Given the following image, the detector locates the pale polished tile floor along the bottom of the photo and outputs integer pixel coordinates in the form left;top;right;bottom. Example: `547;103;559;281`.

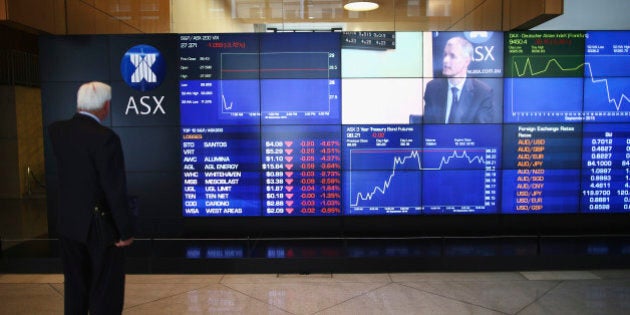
0;269;630;315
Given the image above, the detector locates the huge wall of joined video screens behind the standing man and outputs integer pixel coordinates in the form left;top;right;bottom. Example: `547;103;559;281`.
40;31;630;227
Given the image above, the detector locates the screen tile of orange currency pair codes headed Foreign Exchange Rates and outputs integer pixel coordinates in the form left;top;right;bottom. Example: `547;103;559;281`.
503;124;582;213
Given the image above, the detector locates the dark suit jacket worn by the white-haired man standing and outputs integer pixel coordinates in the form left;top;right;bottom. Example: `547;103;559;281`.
48;114;133;242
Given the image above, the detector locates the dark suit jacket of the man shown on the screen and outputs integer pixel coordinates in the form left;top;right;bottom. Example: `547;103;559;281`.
423;78;500;124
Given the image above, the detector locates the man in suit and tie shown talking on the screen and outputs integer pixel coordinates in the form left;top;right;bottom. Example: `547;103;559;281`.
423;37;499;124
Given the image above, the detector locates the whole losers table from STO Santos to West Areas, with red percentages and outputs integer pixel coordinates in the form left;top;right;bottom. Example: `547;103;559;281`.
182;126;342;216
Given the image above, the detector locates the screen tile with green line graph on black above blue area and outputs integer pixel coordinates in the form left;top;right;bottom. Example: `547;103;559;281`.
504;32;586;123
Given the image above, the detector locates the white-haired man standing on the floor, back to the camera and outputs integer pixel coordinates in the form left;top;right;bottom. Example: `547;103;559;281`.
48;82;134;314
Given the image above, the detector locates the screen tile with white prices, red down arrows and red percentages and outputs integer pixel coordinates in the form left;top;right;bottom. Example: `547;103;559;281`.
262;126;341;216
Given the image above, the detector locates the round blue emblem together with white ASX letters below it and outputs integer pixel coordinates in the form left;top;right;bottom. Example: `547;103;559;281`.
120;45;166;116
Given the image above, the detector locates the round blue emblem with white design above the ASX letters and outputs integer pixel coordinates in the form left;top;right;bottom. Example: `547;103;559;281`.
120;45;166;92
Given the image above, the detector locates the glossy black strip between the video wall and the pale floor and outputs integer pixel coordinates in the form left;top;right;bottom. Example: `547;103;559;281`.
0;236;630;274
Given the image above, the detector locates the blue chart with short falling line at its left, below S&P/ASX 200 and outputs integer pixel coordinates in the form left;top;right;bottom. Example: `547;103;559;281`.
220;51;341;120
